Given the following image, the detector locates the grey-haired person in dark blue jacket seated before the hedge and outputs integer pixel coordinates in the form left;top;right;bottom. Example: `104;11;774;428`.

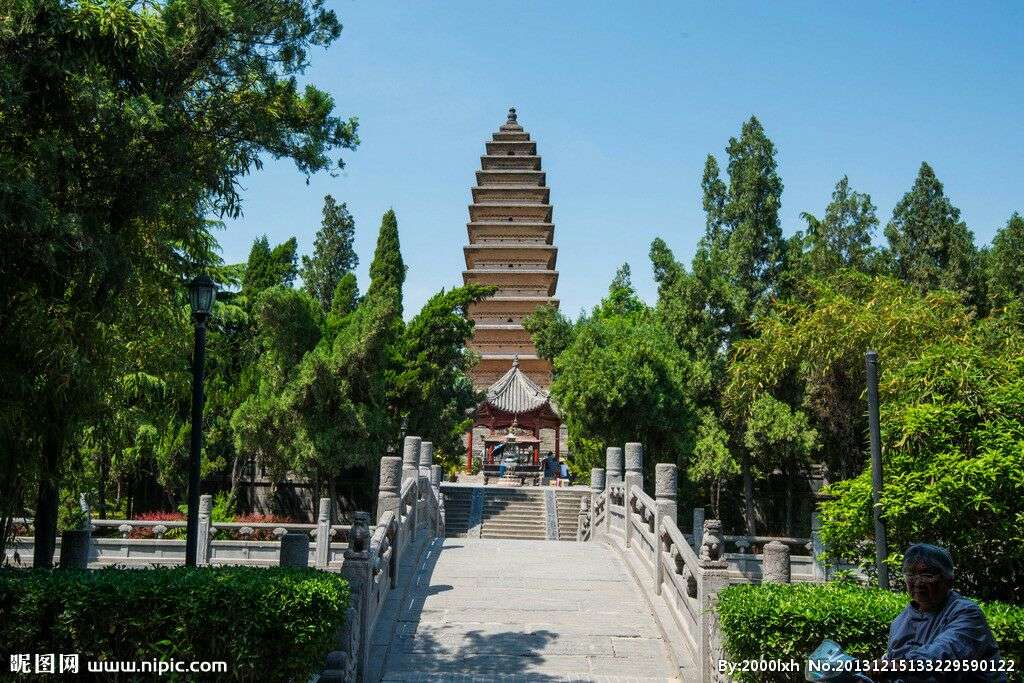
885;543;1007;681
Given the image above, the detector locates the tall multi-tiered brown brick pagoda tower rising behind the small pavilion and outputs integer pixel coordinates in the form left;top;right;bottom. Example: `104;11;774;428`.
462;109;558;389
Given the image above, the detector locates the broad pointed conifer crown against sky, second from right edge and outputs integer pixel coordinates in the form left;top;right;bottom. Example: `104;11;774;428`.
886;163;983;305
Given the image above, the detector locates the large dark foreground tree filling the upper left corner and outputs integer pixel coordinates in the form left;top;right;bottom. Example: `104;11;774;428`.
0;0;357;566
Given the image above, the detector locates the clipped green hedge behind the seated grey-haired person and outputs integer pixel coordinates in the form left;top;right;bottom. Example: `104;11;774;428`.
718;582;1024;680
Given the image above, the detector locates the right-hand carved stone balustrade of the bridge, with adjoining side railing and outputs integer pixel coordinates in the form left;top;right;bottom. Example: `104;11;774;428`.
578;443;827;681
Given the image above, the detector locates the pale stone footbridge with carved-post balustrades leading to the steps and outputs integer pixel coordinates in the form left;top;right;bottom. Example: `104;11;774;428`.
321;437;820;682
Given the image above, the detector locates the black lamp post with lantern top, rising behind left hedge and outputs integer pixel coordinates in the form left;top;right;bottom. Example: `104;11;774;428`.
185;275;217;567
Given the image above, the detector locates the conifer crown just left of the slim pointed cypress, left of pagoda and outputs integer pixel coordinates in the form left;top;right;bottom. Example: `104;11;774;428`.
302;195;359;311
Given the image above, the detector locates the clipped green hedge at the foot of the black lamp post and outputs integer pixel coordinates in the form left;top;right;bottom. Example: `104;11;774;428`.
0;567;349;681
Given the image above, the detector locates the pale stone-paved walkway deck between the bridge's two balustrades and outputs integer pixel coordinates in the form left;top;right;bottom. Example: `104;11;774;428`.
372;539;676;681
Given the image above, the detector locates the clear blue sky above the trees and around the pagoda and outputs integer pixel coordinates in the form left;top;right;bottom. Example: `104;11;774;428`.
218;0;1024;316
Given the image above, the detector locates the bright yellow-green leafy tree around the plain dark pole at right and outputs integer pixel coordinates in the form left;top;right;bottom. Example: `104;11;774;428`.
822;304;1024;602
